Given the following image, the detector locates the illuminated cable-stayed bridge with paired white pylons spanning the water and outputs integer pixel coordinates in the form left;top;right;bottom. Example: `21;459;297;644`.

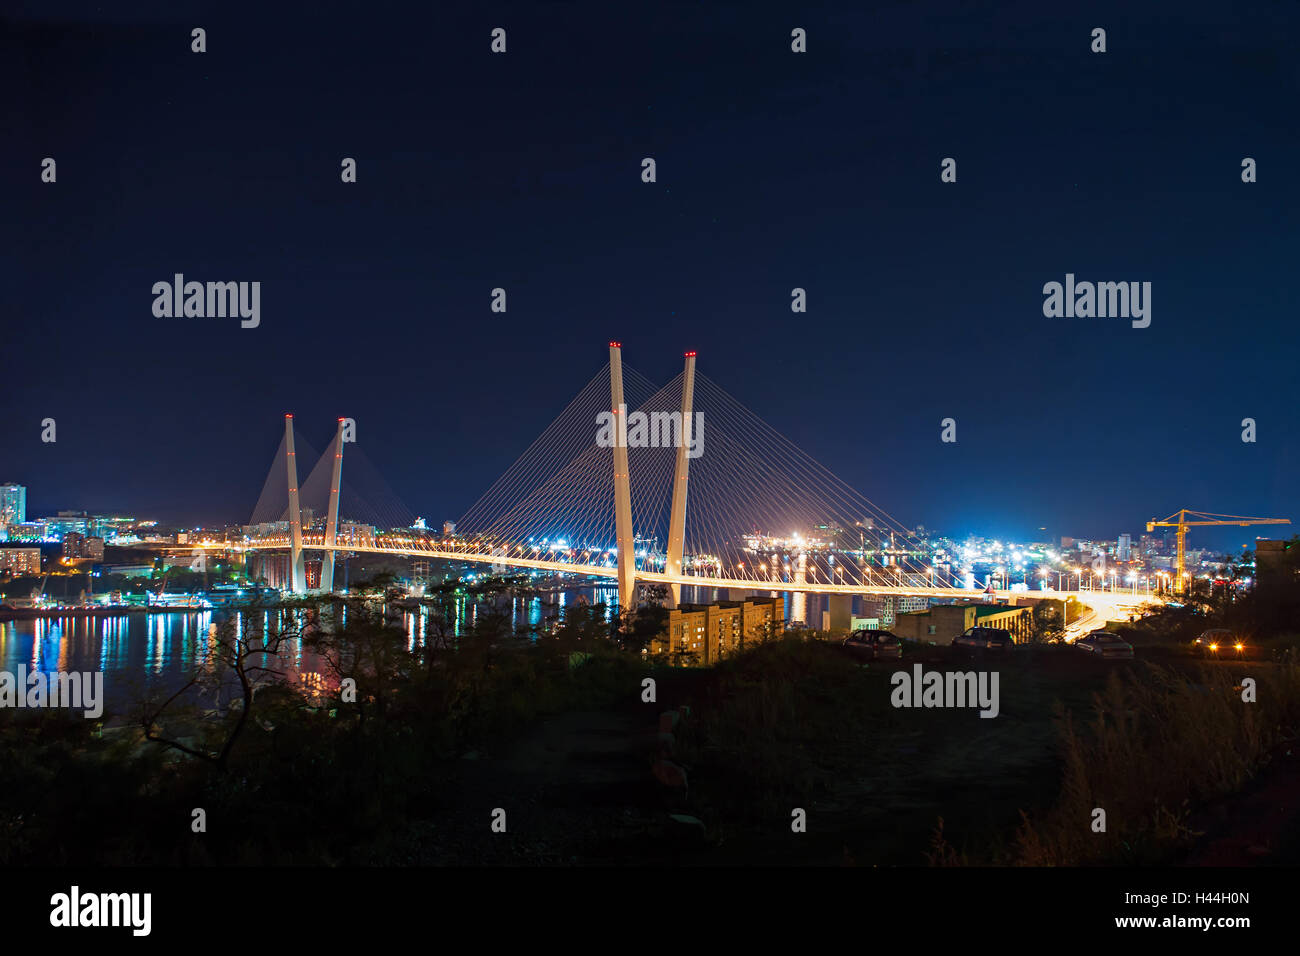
231;342;1086;607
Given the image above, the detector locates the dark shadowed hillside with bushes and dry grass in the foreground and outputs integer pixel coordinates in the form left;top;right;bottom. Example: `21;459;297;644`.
0;556;1300;865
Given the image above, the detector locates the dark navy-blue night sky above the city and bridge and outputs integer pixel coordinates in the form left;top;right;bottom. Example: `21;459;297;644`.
0;0;1300;548
